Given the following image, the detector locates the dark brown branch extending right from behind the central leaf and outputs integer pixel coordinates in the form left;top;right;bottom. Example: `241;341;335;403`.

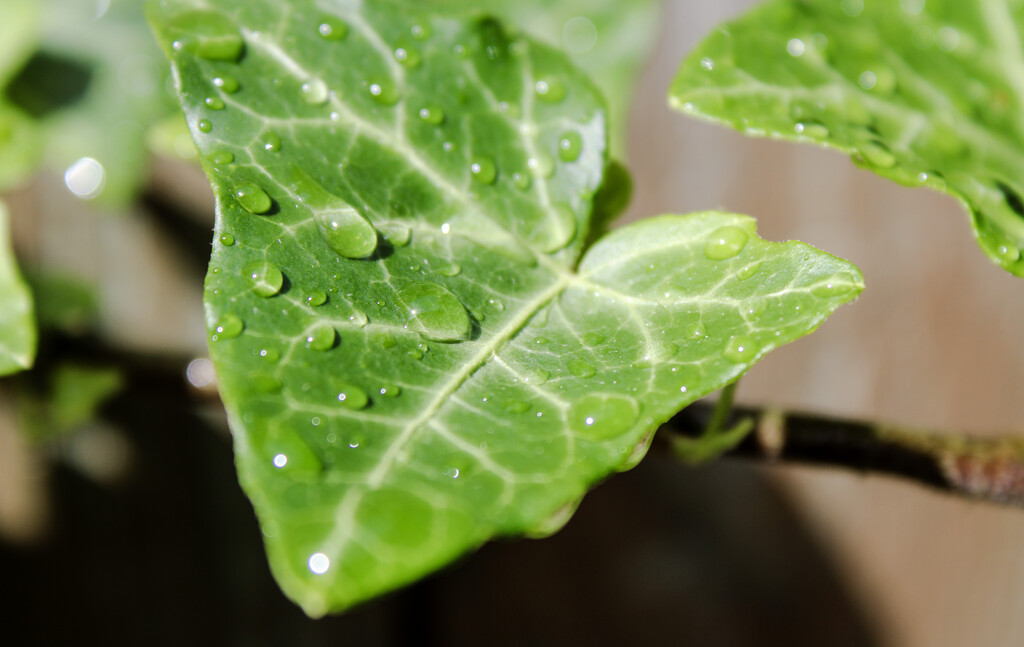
663;402;1024;507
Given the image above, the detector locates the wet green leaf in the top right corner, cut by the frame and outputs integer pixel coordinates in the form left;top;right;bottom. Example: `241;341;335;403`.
671;0;1024;275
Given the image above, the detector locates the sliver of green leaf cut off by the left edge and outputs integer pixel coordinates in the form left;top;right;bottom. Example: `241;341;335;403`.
0;202;36;376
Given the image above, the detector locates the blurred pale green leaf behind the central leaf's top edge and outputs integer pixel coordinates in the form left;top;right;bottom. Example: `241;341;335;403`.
414;0;662;158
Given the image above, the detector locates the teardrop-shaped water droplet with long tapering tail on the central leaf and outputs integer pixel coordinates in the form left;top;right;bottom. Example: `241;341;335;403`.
290;167;377;258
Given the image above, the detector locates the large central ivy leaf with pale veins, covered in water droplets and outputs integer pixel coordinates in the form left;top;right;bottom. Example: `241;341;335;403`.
152;0;861;615
